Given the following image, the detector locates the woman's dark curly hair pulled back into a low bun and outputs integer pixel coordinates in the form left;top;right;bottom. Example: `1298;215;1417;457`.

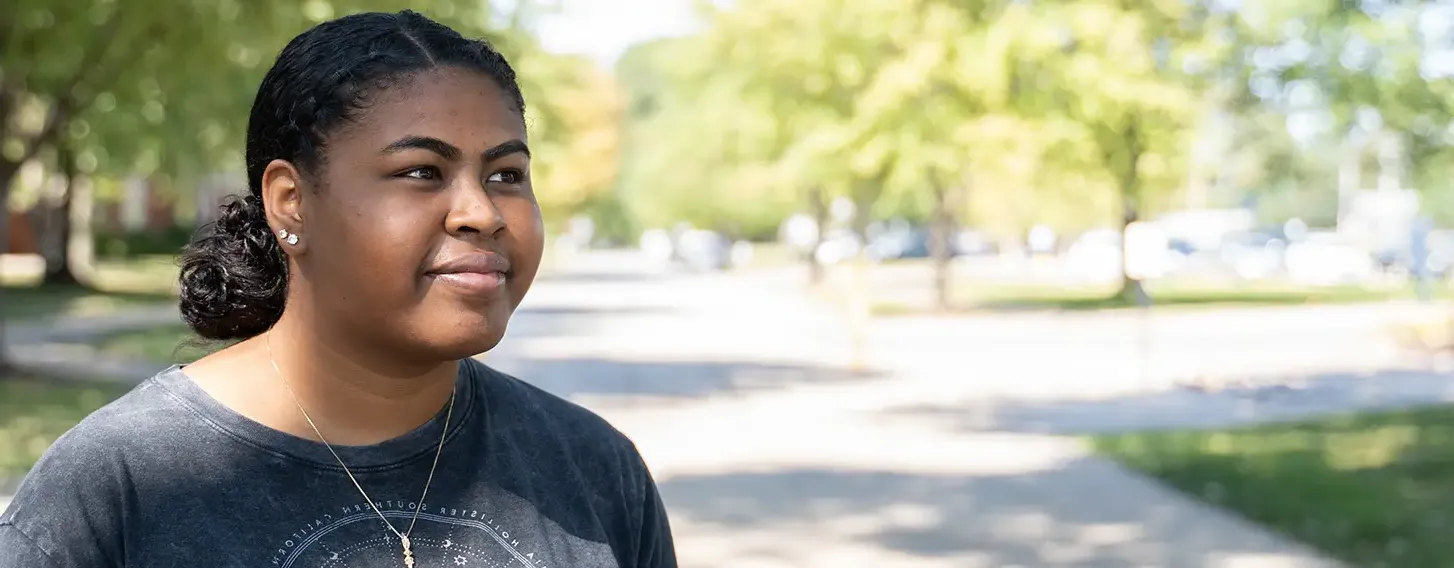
179;10;525;340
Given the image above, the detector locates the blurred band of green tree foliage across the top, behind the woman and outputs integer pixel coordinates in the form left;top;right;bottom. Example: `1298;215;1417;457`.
0;0;1454;302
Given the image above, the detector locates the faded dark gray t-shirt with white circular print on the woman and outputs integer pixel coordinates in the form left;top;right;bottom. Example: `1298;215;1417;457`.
0;360;676;568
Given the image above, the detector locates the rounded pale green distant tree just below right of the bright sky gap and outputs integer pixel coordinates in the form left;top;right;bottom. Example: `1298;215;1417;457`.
616;38;797;238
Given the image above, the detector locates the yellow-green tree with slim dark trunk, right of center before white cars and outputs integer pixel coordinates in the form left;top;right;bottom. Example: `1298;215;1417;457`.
1000;0;1230;299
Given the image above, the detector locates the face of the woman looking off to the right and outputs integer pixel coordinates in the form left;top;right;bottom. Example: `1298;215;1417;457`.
274;68;544;360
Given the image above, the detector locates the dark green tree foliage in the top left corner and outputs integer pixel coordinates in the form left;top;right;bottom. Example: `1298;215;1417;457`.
0;0;286;372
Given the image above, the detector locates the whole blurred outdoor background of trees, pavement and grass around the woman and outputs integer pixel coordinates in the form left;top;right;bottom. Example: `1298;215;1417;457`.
0;0;1454;568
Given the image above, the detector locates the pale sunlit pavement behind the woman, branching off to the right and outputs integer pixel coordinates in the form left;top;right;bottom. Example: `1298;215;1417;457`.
0;254;1451;568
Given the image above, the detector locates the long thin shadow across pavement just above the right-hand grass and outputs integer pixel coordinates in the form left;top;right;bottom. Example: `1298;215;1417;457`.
885;369;1454;434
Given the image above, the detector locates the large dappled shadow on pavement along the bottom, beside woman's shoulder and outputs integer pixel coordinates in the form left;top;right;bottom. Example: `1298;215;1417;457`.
660;459;1317;567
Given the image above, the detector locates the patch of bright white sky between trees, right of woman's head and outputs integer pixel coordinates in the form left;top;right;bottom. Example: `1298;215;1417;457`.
537;0;696;68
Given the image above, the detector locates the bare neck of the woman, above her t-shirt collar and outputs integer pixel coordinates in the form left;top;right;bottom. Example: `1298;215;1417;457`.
253;315;458;446
